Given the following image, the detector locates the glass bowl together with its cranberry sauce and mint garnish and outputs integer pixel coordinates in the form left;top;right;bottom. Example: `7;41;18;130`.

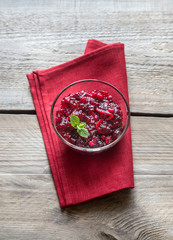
51;79;130;153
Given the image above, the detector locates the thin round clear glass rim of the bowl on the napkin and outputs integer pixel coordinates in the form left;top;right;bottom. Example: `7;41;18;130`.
50;79;130;152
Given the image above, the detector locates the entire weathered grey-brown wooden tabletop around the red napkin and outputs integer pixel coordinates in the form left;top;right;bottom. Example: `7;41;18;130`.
0;0;173;240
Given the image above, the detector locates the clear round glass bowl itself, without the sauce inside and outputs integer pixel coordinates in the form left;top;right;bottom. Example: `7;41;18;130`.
50;79;130;153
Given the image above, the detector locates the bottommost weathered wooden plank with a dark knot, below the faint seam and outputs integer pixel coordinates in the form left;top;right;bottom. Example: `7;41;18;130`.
0;175;173;240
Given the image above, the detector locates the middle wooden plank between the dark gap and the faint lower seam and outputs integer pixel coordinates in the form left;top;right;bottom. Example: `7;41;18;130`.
0;114;173;174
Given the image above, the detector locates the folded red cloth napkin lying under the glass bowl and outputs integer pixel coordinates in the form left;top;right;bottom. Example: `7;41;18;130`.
27;40;134;207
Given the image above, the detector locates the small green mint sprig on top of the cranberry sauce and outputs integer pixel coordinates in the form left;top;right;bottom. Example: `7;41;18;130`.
70;114;89;138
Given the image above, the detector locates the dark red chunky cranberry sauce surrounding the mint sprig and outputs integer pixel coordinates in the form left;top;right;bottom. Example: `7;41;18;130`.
56;90;123;148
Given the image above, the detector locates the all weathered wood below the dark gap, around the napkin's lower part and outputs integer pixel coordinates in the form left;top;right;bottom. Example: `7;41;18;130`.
0;114;173;240
